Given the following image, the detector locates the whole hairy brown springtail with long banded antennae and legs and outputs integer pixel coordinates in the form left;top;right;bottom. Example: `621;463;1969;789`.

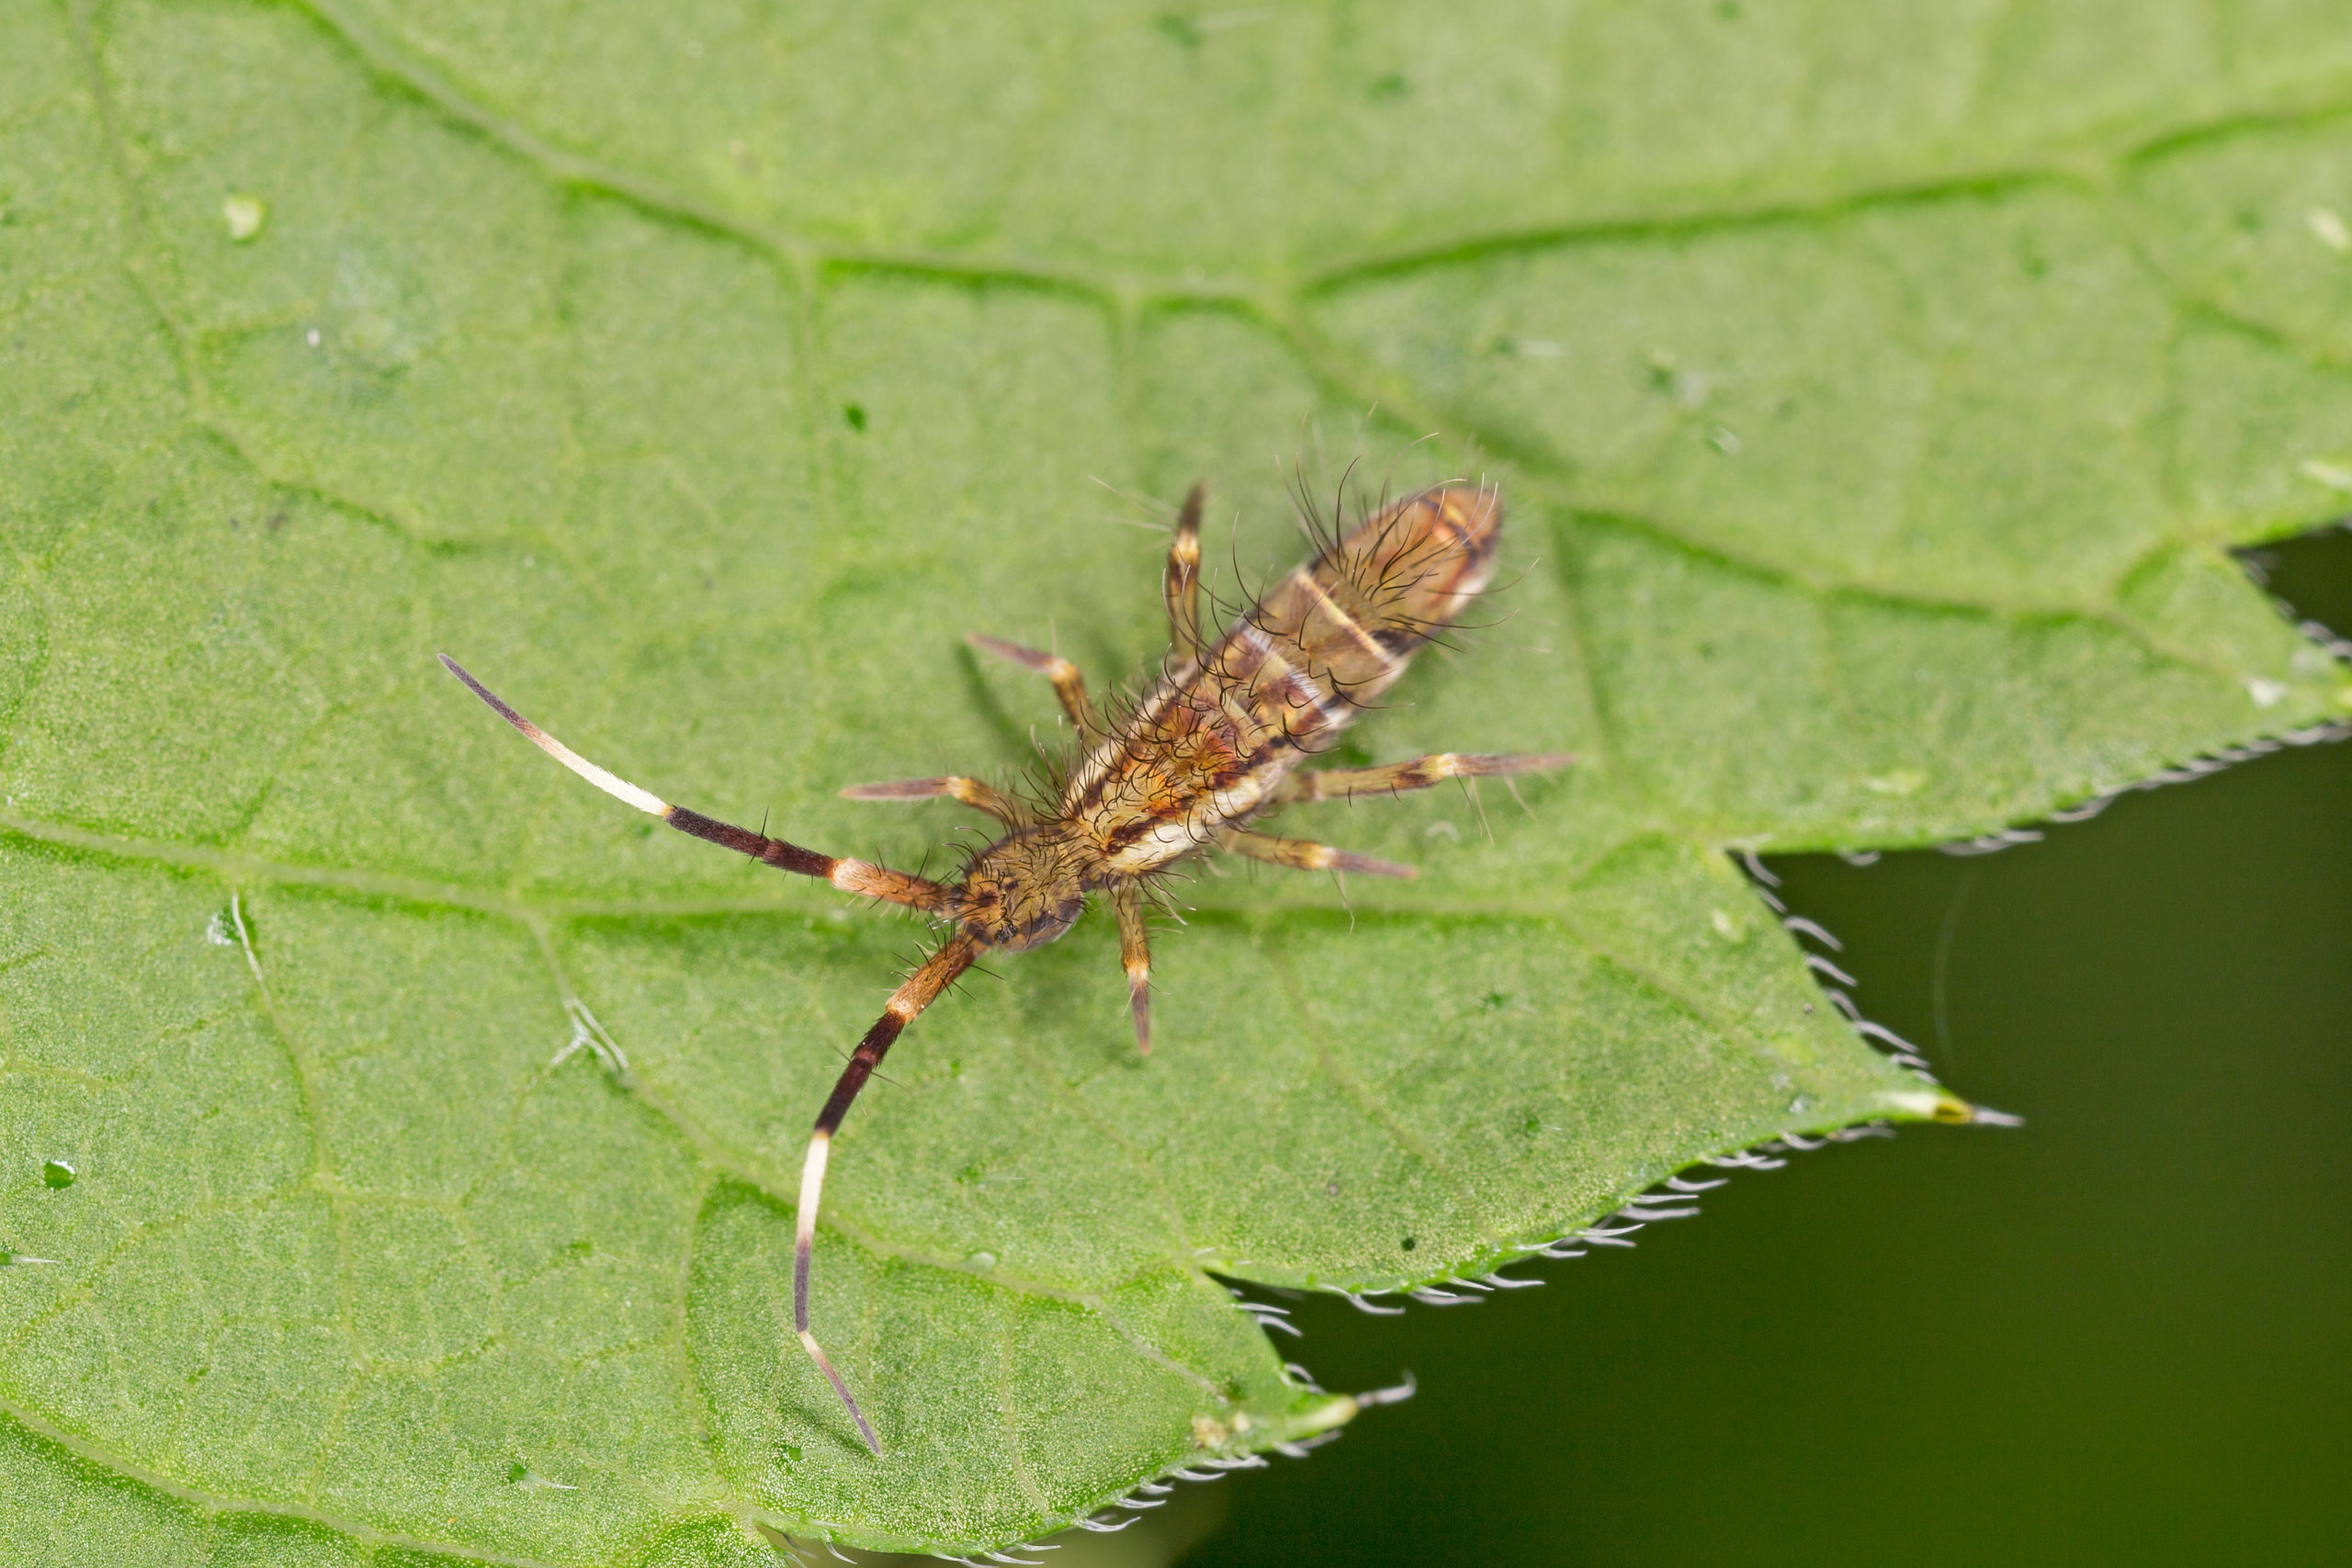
442;479;1574;1455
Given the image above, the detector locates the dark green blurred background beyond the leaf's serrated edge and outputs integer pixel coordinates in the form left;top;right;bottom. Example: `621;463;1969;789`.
1128;529;2352;1568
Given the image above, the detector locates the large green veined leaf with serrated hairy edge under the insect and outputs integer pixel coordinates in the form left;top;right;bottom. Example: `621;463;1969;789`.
0;0;2352;1563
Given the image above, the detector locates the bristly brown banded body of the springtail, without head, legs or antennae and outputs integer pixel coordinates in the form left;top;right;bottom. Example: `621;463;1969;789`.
1061;487;1503;877
